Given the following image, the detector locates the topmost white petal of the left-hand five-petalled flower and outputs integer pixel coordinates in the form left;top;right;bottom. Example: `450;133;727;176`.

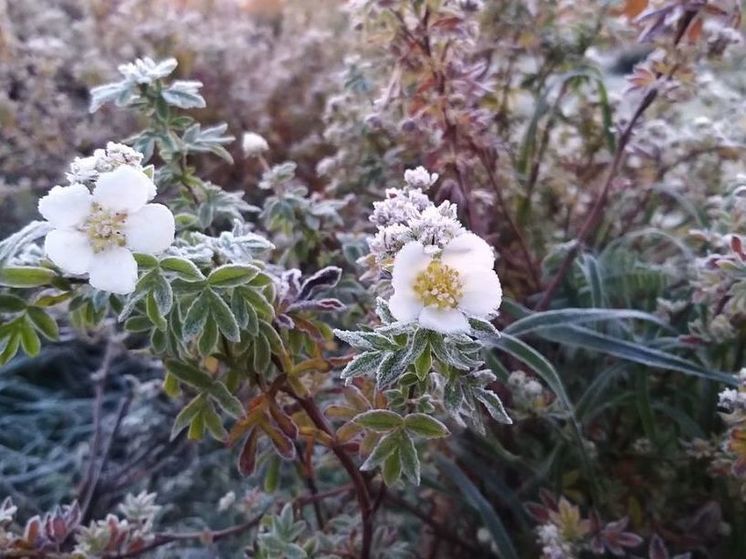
93;165;155;212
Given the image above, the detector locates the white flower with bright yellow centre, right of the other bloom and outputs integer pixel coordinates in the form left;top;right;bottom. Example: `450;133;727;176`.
389;233;502;334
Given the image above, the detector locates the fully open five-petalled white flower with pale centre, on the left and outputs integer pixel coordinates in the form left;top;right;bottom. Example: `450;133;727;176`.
39;166;174;294
